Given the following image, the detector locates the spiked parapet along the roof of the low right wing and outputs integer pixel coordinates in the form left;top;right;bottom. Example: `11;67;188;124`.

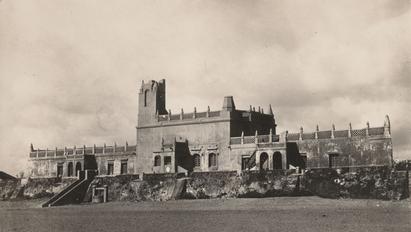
230;115;391;144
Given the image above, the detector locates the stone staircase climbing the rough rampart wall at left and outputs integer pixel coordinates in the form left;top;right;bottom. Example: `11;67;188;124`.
42;170;96;208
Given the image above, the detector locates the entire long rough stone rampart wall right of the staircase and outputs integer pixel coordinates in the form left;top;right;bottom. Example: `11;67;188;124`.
75;167;409;204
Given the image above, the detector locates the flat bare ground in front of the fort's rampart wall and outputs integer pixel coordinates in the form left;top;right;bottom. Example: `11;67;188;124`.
0;197;411;232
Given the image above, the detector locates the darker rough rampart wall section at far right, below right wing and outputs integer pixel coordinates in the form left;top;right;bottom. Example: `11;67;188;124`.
302;167;409;200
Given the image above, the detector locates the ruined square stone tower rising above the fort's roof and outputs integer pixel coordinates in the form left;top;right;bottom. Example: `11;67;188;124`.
137;79;167;126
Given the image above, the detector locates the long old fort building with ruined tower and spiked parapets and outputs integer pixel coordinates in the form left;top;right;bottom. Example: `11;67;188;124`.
29;80;393;178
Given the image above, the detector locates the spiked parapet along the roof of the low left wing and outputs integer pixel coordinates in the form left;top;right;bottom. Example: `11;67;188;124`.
29;142;136;159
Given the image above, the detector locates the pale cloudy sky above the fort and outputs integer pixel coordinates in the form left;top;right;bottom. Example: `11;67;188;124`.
0;0;411;175
